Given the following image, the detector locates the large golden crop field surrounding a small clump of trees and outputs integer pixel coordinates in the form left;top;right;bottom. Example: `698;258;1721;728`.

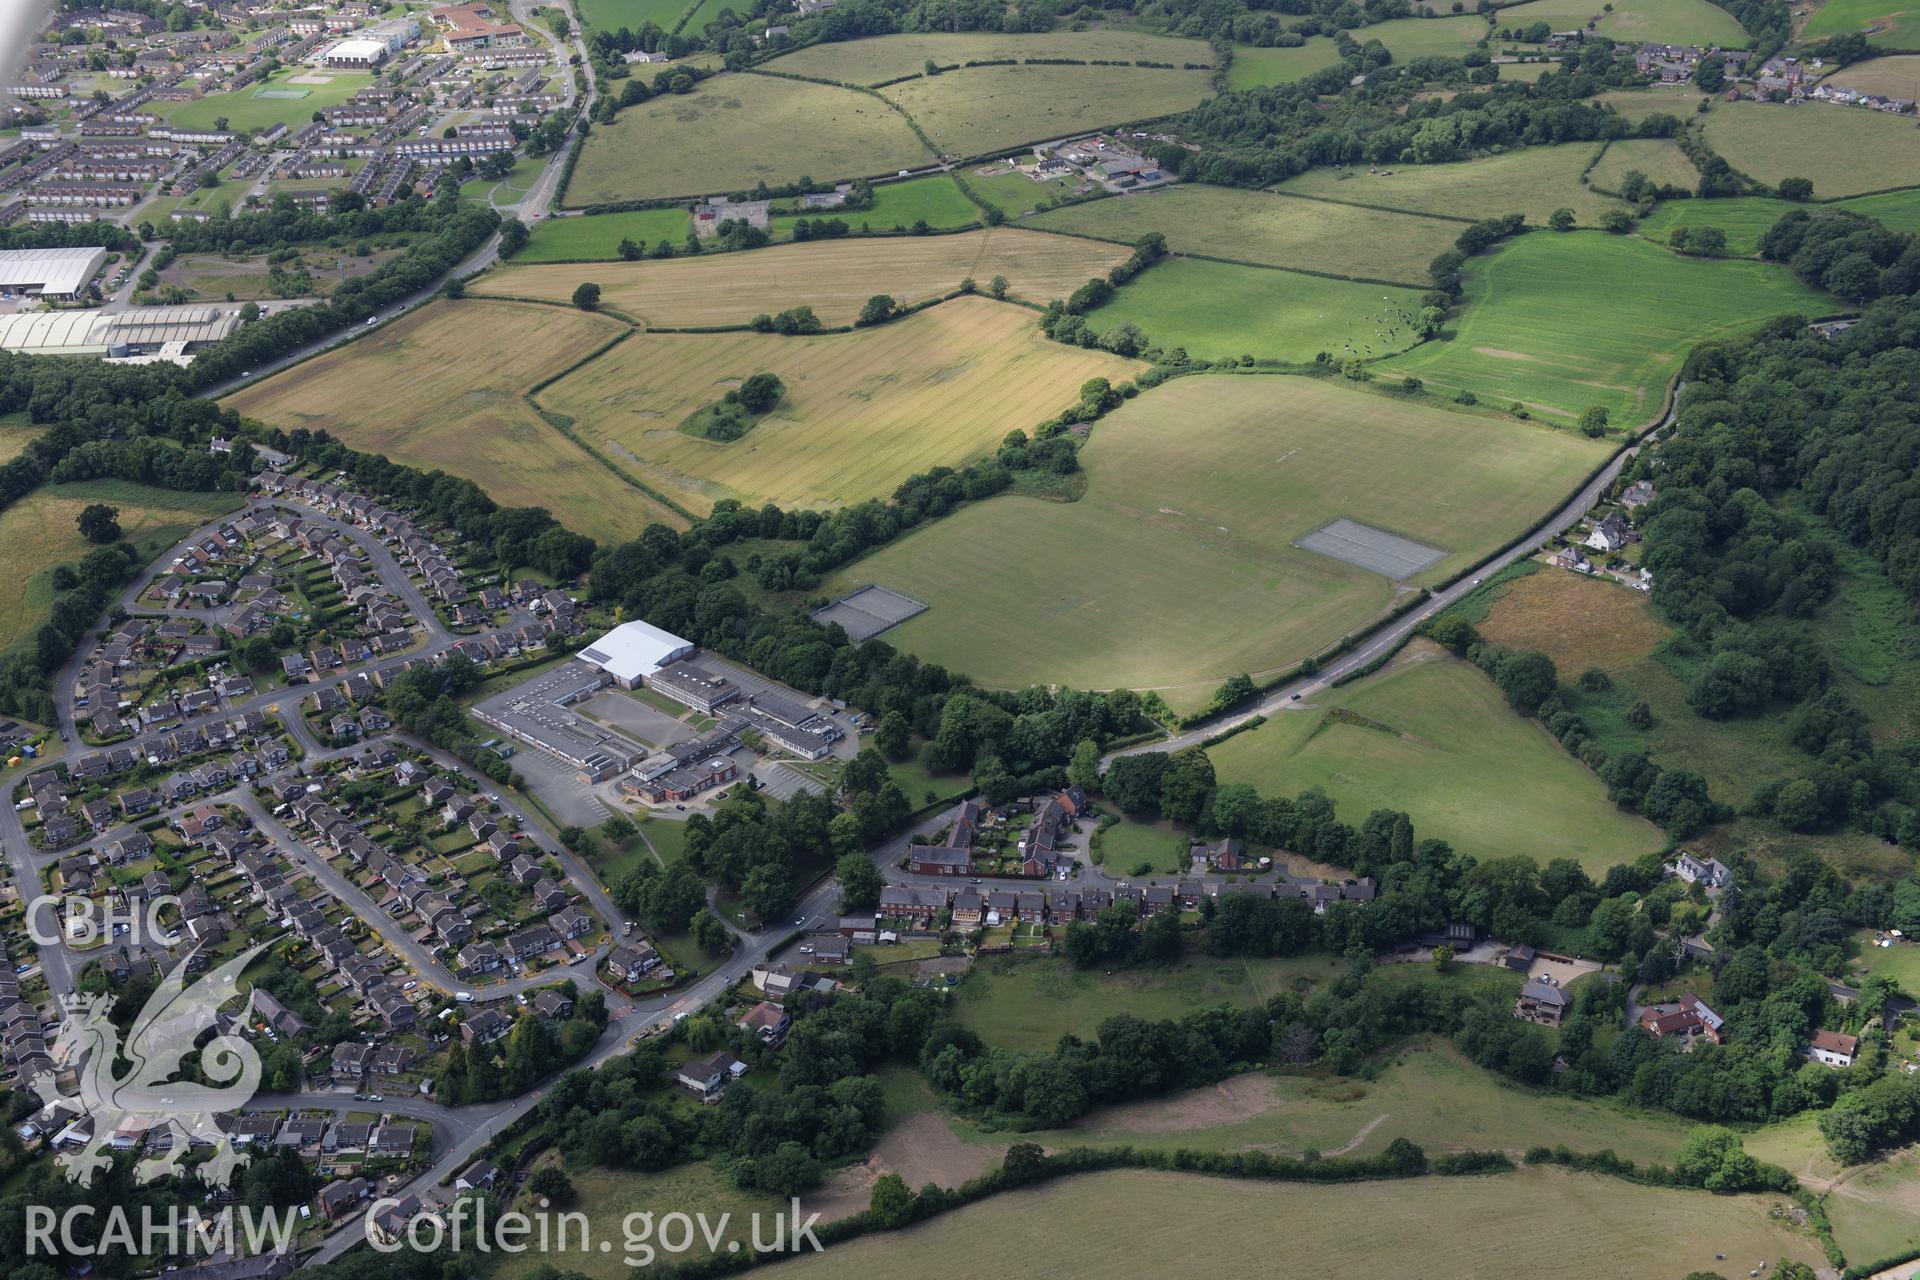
540;297;1142;510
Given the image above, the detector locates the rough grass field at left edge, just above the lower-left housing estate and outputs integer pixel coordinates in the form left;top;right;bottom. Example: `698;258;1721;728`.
0;485;240;652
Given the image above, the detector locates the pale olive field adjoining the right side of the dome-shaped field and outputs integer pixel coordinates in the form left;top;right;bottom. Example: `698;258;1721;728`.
883;67;1212;160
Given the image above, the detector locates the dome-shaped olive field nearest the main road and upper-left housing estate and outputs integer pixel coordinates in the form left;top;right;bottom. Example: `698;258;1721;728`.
566;73;933;205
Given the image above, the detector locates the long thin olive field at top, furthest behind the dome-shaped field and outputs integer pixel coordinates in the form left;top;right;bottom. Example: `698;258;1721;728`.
766;31;1213;84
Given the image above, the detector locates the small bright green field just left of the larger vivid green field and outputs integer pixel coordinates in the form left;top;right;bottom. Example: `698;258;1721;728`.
1087;257;1425;365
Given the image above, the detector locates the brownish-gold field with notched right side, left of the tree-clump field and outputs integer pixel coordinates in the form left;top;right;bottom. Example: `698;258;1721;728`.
223;301;685;541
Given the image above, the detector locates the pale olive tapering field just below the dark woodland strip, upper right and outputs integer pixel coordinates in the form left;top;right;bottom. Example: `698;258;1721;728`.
1275;142;1620;226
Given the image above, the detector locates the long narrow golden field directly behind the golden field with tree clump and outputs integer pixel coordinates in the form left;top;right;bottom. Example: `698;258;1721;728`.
468;228;1131;328
